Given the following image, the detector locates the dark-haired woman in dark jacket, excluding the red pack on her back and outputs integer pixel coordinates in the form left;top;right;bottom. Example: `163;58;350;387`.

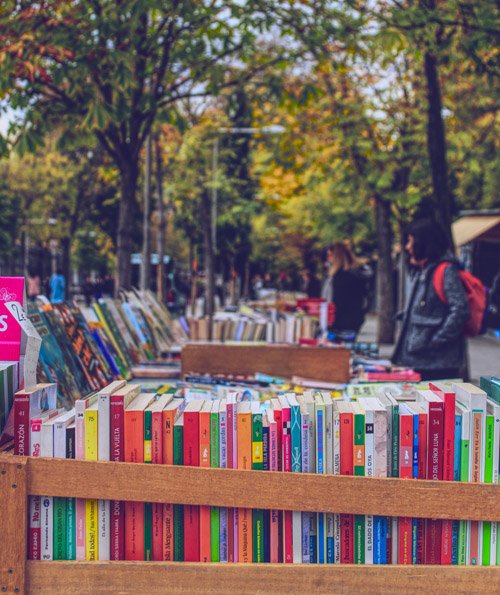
392;220;470;380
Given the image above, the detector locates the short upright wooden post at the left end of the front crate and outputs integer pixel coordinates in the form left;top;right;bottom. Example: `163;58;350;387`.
0;455;28;593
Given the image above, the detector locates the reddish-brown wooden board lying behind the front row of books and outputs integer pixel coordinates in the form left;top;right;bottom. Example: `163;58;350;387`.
181;343;350;383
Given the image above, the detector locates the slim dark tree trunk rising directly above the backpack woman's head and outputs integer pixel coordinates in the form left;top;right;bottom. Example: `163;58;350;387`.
424;52;453;243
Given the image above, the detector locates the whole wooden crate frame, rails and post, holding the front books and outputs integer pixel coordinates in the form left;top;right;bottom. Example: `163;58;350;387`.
0;454;500;594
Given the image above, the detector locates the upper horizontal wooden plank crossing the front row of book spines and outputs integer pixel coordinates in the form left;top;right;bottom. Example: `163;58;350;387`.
22;455;500;521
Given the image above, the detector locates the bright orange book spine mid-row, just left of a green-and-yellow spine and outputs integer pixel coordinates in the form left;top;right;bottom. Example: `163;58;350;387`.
237;413;253;562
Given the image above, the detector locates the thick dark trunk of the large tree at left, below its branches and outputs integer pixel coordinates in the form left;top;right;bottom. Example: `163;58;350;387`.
116;161;139;290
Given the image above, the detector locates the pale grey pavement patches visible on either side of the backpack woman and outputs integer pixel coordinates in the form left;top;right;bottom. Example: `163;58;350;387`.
358;315;500;382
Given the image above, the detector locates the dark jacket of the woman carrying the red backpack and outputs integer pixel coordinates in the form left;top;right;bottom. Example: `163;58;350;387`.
392;257;469;370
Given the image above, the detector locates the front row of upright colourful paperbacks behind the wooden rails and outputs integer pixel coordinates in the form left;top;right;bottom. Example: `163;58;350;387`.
14;378;500;565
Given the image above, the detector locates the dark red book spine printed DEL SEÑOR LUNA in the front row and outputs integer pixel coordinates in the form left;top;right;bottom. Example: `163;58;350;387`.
424;402;444;564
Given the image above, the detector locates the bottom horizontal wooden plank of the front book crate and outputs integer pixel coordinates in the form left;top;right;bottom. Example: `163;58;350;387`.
28;562;500;594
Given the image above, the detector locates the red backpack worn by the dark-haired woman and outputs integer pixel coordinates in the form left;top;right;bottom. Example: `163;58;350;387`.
432;262;488;337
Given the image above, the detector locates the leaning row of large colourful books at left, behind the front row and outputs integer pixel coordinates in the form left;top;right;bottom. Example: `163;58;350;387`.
24;292;186;407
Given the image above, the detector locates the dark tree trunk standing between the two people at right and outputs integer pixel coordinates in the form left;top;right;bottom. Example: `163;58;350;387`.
375;195;394;343
